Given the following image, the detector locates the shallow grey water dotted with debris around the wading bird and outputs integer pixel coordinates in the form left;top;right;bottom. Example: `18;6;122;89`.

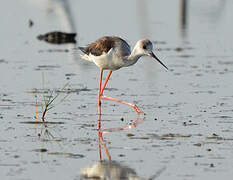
0;0;233;180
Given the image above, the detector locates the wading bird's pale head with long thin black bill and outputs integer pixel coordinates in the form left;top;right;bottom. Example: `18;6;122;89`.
136;39;168;70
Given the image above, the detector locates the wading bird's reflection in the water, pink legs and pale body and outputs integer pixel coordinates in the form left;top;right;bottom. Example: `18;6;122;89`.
81;115;145;180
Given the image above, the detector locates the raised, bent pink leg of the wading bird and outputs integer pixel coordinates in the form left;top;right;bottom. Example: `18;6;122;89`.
99;70;145;114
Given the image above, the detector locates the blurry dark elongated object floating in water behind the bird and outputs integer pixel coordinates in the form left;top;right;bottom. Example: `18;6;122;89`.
37;31;76;44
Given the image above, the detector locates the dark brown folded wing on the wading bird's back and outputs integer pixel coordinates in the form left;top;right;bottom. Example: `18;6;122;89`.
79;36;125;56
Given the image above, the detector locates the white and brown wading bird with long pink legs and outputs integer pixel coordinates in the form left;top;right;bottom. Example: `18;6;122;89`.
79;36;168;118
